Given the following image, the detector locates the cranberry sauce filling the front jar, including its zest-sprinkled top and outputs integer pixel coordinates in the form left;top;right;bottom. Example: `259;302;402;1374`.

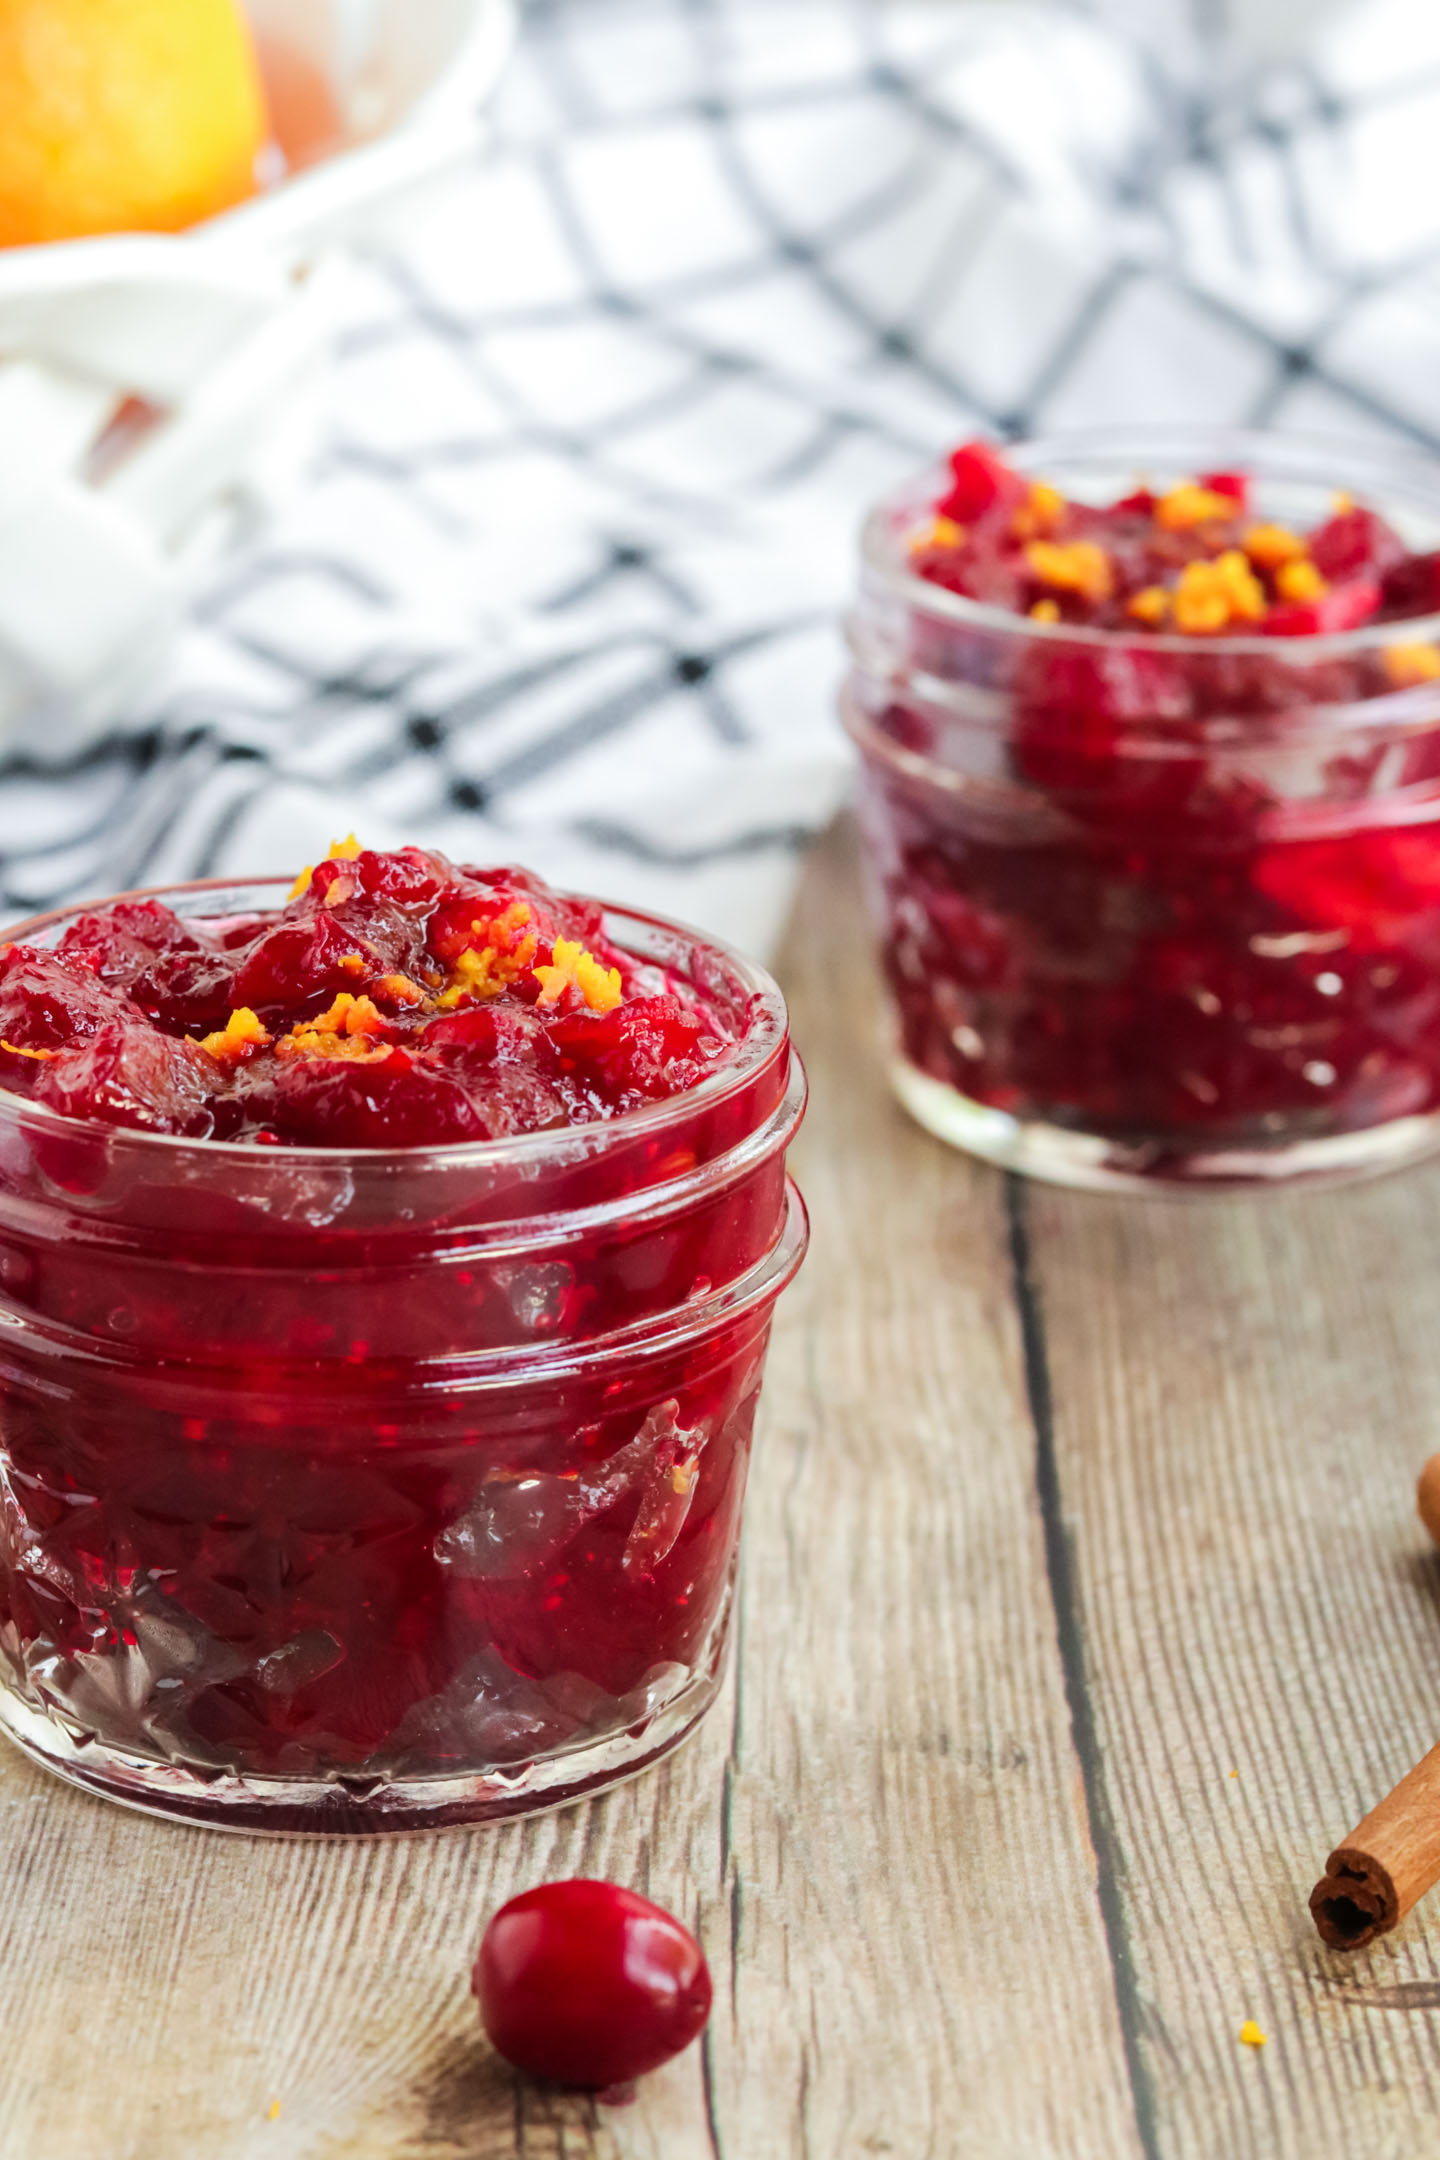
0;851;805;1830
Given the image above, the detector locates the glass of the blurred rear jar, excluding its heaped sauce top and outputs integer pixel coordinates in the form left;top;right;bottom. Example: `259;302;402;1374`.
842;430;1440;1190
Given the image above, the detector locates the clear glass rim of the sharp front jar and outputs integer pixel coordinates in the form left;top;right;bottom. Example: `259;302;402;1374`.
0;877;790;1175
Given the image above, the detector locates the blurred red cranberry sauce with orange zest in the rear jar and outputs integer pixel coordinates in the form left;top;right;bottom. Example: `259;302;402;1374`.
855;443;1440;1145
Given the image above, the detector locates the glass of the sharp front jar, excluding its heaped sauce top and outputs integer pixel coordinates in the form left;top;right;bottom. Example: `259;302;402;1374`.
0;881;805;1832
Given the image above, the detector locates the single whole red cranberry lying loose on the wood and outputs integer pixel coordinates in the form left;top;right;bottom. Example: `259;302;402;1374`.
471;1881;710;2091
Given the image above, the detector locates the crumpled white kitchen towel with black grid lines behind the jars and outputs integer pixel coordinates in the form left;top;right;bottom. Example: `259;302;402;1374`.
0;0;1440;950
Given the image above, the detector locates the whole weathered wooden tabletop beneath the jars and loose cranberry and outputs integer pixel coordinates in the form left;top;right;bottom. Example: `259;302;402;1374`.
0;812;1440;2160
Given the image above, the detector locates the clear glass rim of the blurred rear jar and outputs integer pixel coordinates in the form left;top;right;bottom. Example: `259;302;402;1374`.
859;426;1440;652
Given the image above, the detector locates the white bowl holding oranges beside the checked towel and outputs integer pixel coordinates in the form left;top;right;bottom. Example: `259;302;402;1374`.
0;0;516;747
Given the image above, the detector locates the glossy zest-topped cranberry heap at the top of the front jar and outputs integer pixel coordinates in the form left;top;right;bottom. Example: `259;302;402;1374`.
0;842;730;1147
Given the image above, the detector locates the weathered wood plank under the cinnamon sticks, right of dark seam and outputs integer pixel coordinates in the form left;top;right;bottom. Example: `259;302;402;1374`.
1021;1169;1440;2160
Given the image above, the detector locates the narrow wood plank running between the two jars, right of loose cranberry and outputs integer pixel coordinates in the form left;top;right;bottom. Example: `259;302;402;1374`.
712;820;1136;2160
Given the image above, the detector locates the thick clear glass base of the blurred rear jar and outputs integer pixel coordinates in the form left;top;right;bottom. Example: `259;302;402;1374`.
889;1056;1440;1194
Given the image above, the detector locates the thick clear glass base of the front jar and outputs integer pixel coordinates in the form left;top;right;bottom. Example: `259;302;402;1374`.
0;1642;725;1838
